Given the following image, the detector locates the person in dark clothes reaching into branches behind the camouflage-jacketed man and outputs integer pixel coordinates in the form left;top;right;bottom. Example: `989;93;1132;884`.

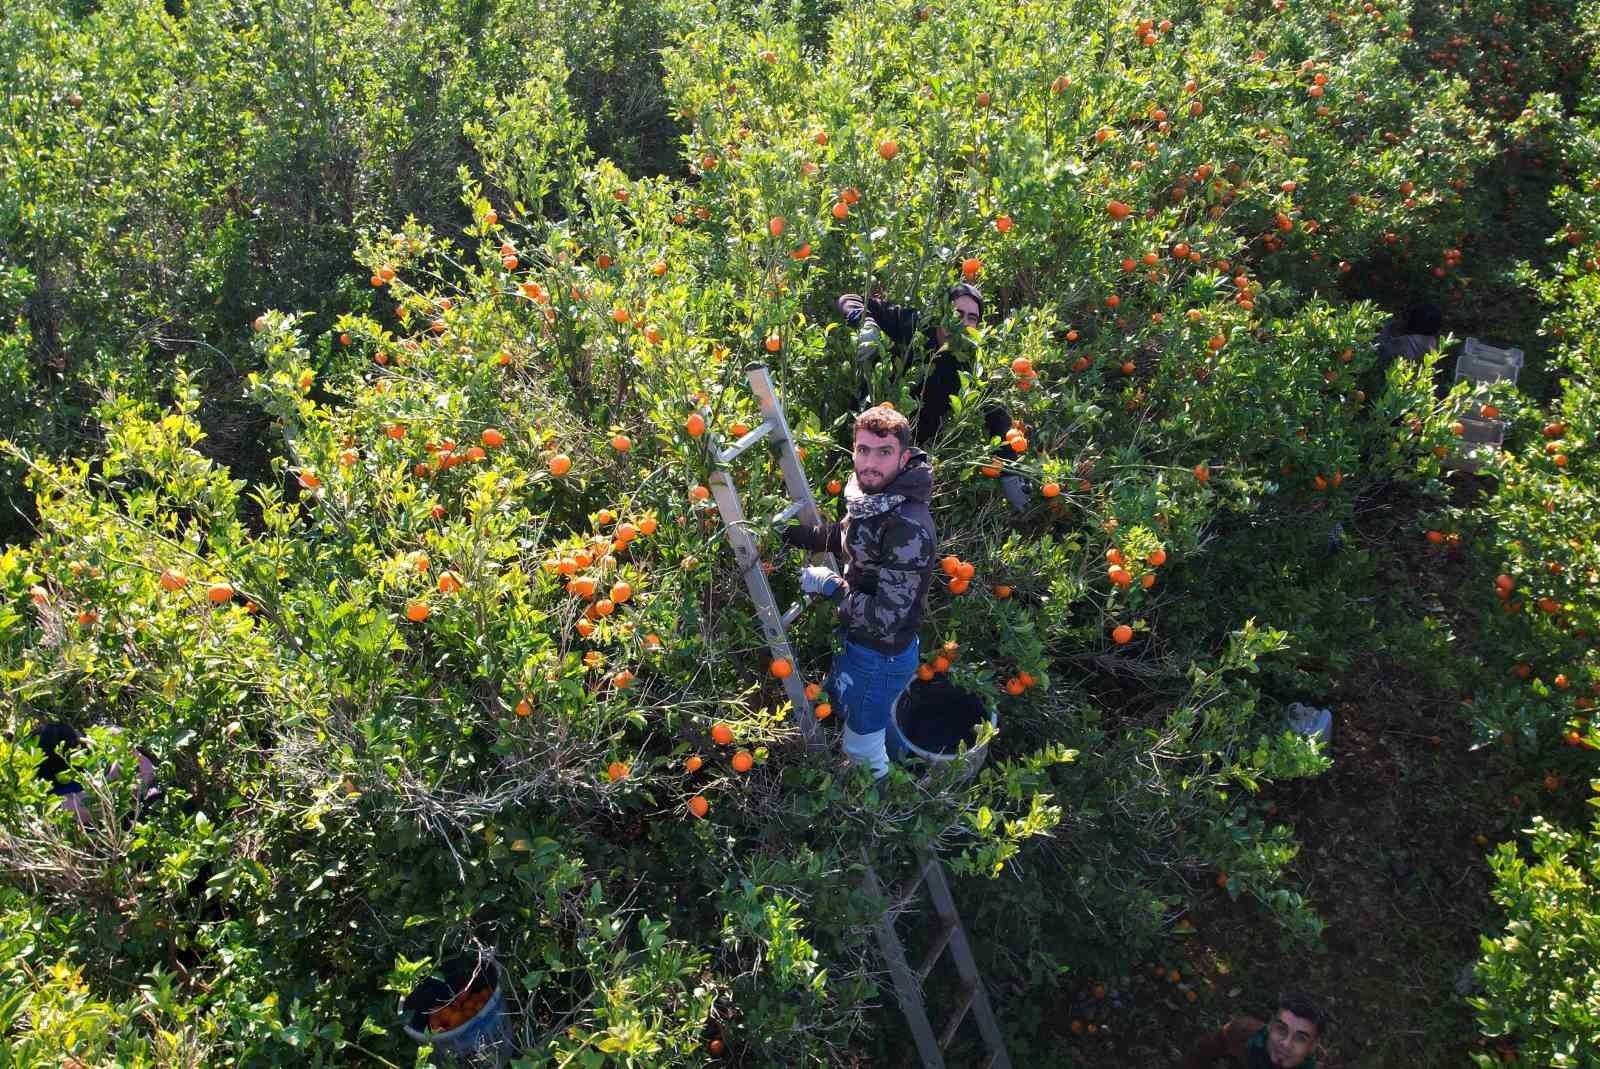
837;282;1027;512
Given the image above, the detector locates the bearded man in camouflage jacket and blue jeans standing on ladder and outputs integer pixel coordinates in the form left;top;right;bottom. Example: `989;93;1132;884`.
782;405;938;776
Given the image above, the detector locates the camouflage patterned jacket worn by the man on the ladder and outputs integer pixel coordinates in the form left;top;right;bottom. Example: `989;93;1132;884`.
797;450;938;655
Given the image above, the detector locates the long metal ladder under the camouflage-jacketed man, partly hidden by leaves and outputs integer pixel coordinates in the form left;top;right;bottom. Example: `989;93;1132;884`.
702;363;1011;1069
